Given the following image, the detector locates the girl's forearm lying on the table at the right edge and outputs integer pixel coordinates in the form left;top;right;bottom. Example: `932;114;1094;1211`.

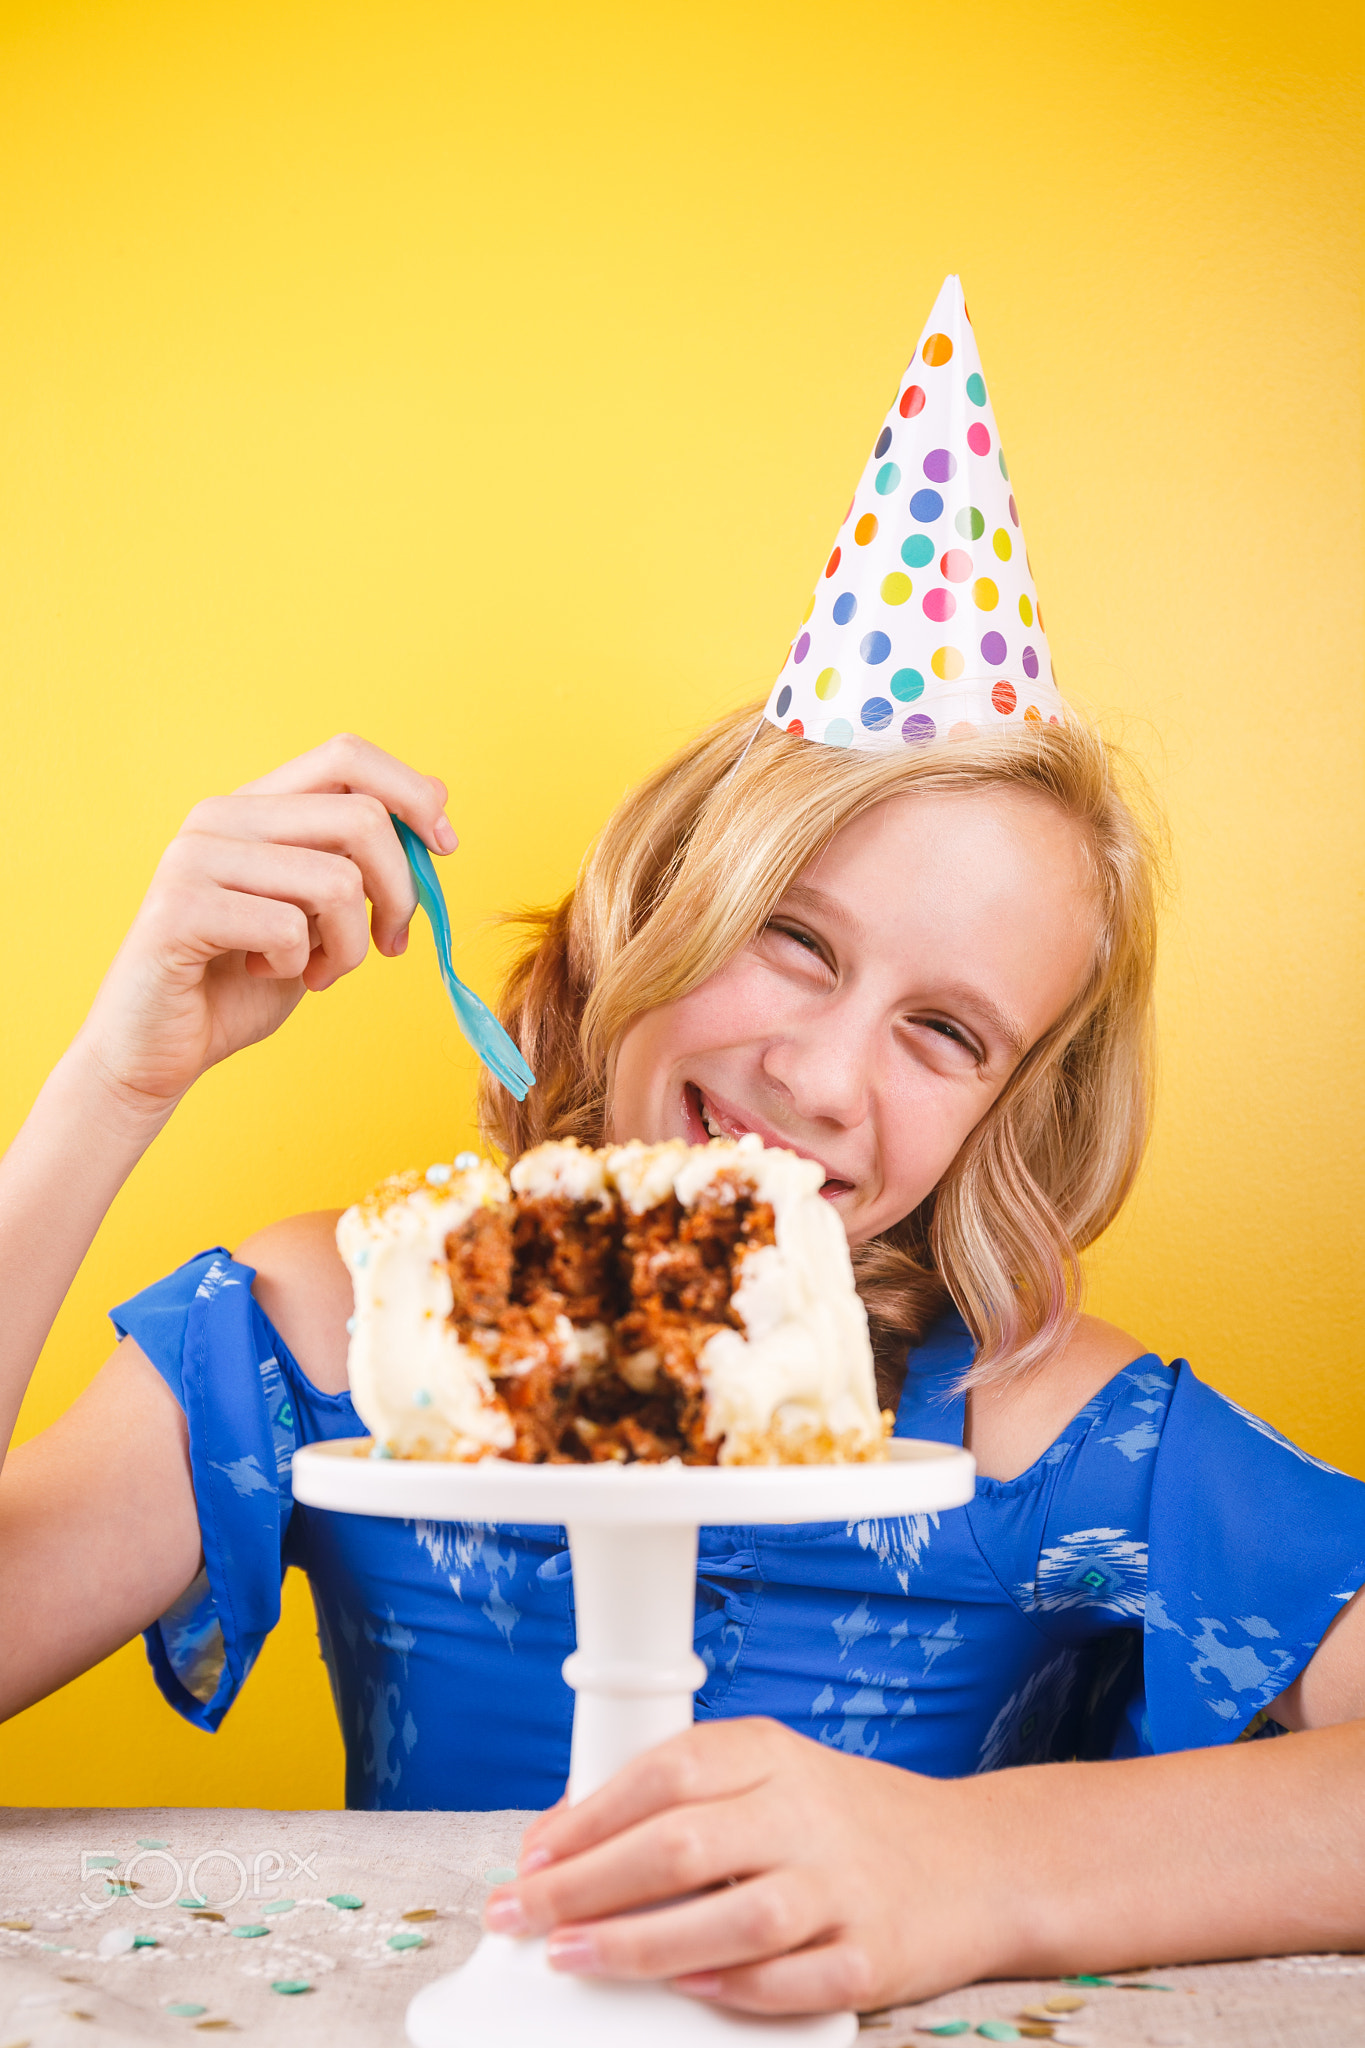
978;1720;1365;1976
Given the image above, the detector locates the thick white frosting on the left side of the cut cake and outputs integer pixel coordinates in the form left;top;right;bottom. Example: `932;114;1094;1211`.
336;1159;516;1458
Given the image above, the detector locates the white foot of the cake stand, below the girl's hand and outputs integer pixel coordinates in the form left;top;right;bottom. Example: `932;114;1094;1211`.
407;1933;857;2048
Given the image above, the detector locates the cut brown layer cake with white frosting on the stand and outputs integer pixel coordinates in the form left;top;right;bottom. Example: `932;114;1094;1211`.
338;1137;888;1464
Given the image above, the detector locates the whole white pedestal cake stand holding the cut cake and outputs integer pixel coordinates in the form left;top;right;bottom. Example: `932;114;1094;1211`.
295;1438;976;2048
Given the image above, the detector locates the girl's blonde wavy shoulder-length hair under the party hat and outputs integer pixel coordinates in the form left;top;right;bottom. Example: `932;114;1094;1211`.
481;707;1160;1399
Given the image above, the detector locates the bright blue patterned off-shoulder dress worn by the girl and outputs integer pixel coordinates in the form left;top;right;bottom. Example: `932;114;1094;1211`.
113;1251;1365;1808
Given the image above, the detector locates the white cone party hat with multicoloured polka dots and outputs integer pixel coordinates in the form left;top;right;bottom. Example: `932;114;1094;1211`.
765;276;1066;748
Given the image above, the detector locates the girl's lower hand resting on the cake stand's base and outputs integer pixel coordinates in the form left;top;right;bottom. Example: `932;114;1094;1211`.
485;1720;1023;2013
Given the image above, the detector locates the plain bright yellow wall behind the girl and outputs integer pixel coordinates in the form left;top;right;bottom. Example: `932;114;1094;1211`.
0;0;1365;1806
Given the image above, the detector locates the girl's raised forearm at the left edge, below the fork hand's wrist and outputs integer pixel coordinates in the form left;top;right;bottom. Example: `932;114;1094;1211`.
0;1038;174;1462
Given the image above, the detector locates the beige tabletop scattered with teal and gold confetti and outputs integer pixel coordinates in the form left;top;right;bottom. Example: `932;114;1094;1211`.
0;1806;1365;2048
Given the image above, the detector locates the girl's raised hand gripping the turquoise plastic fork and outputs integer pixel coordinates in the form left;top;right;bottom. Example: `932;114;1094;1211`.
74;733;456;1122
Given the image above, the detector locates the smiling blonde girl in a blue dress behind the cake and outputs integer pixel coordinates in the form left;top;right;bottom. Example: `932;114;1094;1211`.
0;713;1365;2011
